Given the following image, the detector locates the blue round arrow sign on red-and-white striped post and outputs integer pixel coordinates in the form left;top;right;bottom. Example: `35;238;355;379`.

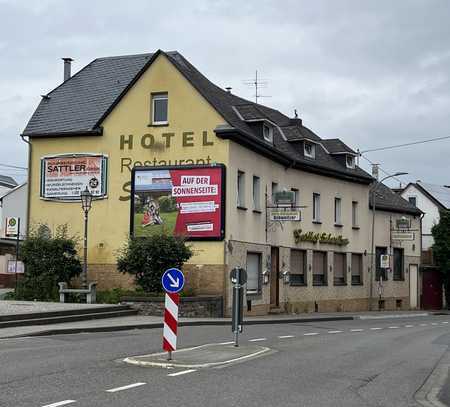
161;268;184;360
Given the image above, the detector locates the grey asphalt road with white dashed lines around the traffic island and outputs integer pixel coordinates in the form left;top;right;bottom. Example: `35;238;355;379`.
0;316;450;407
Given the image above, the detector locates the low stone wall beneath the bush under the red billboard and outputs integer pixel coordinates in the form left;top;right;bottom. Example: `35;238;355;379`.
121;296;223;318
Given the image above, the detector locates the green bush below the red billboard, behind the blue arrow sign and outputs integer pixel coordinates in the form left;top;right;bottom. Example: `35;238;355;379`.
117;234;192;293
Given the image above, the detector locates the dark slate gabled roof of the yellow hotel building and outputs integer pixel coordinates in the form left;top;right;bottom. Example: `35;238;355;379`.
23;50;373;184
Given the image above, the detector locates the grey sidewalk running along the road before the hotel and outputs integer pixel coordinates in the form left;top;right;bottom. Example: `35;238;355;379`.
0;310;436;339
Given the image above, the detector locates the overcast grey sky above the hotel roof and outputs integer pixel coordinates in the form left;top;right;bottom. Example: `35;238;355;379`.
0;0;450;185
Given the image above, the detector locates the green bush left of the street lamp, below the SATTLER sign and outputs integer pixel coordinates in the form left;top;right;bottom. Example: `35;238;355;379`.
15;225;81;301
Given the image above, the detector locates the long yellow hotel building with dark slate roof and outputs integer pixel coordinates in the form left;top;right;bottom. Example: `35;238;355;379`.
22;51;421;313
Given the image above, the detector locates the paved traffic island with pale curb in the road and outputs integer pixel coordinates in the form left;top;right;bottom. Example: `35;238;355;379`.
123;342;273;369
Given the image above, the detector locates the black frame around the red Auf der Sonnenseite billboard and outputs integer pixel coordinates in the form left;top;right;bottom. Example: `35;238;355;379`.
130;164;227;241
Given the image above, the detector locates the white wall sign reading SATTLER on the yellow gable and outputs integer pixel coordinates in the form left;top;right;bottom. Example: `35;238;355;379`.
41;154;108;201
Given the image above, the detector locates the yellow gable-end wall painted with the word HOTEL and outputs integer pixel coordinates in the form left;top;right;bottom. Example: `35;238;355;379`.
30;55;229;278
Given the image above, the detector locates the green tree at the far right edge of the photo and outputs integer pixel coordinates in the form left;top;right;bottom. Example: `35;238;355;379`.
431;210;450;309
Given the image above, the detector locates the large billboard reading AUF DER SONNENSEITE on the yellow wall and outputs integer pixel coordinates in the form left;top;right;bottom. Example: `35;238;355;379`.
130;164;225;240
